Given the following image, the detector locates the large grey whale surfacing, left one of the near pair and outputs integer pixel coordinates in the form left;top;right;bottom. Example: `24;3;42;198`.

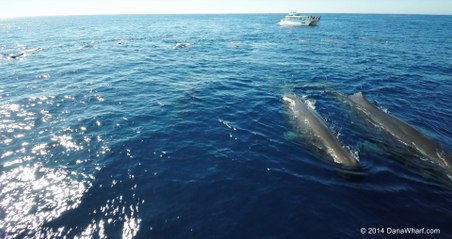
283;94;359;169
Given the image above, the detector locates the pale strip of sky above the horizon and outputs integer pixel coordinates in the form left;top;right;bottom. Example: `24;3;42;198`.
0;0;452;18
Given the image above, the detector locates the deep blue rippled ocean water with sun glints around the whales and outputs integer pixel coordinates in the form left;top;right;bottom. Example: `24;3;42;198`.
0;14;452;238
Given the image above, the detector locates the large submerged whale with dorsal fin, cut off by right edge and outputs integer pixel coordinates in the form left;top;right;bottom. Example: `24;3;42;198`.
347;92;452;173
